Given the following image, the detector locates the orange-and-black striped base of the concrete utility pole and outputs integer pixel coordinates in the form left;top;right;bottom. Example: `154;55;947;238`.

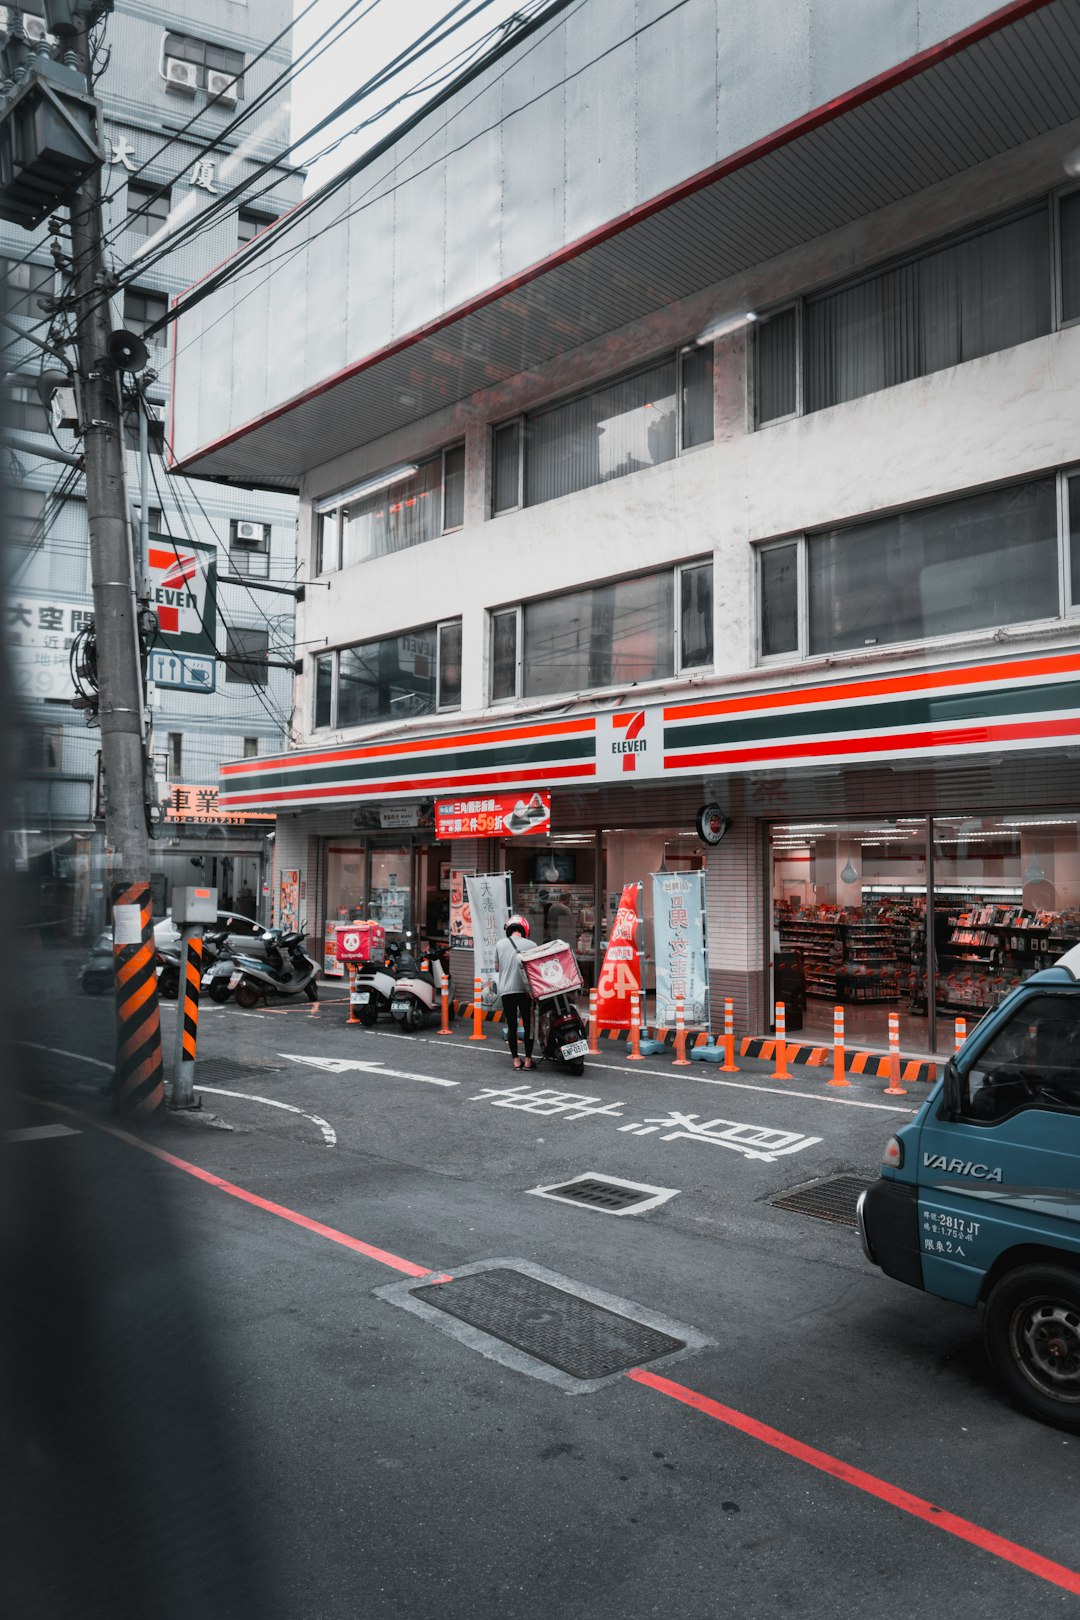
112;883;165;1119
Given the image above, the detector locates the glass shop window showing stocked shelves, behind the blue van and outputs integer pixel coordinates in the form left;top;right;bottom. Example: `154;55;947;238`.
771;810;1080;1051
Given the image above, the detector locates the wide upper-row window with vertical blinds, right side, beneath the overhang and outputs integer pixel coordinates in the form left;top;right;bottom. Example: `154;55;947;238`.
756;198;1049;424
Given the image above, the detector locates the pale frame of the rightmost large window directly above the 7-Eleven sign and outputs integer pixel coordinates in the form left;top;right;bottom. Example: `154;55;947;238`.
751;462;1080;669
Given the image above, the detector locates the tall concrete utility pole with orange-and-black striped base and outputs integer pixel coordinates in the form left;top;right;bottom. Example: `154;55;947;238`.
71;18;164;1116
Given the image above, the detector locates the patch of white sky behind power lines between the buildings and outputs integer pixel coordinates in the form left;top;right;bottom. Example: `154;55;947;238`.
293;0;534;191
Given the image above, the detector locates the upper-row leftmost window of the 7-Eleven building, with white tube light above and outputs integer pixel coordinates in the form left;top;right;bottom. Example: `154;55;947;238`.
316;444;465;573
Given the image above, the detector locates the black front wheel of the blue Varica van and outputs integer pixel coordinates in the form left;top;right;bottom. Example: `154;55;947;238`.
983;1265;1080;1432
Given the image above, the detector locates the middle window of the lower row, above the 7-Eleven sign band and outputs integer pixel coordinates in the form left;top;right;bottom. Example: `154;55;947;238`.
491;562;712;703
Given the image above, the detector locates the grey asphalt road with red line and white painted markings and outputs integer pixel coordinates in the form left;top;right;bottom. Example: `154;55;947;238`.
8;972;1080;1620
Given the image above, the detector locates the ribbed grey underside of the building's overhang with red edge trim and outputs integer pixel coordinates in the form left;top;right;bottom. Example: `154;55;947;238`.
169;0;1080;489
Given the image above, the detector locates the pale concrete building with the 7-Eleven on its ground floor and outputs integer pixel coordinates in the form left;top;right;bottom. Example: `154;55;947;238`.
173;0;1080;1050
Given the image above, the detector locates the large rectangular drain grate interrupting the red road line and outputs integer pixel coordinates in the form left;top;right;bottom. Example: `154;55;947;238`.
411;1267;687;1379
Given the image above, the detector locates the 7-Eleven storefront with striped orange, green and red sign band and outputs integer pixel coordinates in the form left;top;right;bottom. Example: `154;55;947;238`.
220;651;1080;1051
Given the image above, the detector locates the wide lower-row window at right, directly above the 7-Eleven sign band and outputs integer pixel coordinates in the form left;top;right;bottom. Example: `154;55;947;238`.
759;476;1061;658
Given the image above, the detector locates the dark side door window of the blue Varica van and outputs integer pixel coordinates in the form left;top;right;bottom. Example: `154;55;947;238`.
959;991;1080;1123
